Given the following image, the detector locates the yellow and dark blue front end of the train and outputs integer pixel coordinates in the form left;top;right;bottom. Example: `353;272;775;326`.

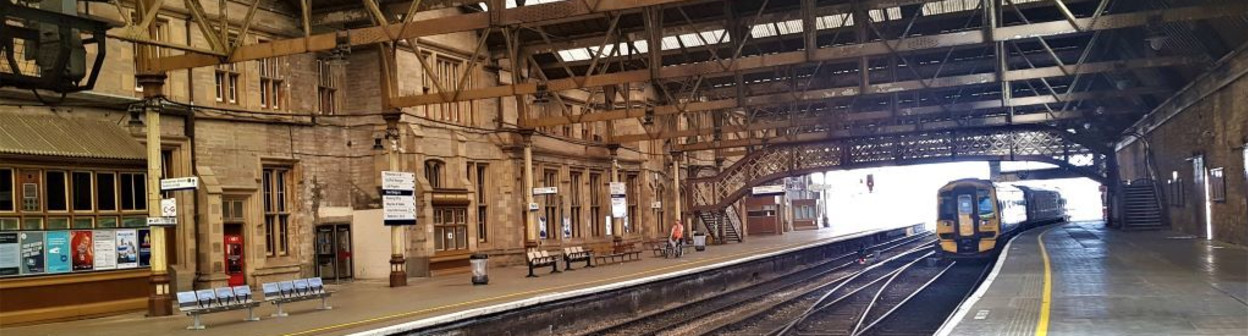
936;180;1000;257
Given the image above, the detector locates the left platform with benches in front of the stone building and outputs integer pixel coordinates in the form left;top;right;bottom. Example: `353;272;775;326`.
0;225;912;336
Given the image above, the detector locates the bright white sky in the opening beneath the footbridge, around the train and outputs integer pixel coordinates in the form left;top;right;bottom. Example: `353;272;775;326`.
811;161;1101;232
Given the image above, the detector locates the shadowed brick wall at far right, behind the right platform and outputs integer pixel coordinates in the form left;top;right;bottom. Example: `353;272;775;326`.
1118;49;1248;245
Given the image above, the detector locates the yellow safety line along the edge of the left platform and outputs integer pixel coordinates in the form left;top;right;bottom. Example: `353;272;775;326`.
286;232;859;336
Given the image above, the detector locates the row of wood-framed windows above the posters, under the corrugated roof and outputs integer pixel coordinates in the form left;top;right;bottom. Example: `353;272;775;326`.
0;166;147;231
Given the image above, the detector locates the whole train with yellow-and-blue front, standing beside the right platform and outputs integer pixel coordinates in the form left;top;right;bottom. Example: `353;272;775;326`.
935;179;1070;259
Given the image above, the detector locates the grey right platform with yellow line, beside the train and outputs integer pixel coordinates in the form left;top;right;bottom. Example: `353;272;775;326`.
937;222;1248;335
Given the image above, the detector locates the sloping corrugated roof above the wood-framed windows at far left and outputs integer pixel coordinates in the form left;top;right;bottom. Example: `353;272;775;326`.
0;114;146;160
